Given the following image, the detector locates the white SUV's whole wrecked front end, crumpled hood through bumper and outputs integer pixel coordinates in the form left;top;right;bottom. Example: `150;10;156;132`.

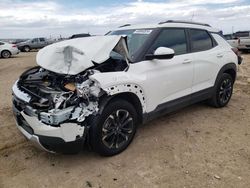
13;36;129;153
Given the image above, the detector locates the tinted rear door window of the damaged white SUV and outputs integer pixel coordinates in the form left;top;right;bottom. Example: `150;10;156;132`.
190;29;213;52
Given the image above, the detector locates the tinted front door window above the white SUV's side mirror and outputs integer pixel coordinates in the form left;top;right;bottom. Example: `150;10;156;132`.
150;29;187;55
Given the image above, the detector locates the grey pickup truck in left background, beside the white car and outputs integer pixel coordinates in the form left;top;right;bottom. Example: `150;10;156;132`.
17;37;52;52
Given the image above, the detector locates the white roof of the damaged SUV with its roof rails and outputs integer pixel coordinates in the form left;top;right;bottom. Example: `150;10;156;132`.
115;20;220;33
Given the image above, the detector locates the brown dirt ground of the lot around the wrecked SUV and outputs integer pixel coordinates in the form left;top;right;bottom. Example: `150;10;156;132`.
0;52;250;188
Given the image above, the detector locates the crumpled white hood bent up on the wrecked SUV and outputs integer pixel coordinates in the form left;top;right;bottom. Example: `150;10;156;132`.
36;35;128;75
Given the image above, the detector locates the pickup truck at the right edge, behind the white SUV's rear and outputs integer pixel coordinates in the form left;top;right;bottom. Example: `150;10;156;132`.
224;31;250;52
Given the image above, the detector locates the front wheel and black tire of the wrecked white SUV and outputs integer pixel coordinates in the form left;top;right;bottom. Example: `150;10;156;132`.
89;99;137;156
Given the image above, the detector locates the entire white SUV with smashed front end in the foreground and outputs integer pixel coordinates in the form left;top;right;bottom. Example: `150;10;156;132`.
13;21;238;156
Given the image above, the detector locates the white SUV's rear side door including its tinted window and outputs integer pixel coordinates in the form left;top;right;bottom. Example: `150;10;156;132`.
189;29;224;93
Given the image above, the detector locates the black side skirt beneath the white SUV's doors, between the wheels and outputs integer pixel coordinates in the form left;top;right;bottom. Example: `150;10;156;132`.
143;87;215;123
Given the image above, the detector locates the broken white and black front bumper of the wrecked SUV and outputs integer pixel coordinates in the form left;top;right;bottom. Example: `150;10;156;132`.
13;84;87;153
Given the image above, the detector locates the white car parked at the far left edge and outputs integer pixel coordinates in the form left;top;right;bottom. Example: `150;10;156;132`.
0;41;19;58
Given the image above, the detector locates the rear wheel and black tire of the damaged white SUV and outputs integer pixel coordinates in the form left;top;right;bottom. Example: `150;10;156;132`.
209;73;234;108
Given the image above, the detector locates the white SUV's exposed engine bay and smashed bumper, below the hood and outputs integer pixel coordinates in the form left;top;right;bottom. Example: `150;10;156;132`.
13;67;105;152
